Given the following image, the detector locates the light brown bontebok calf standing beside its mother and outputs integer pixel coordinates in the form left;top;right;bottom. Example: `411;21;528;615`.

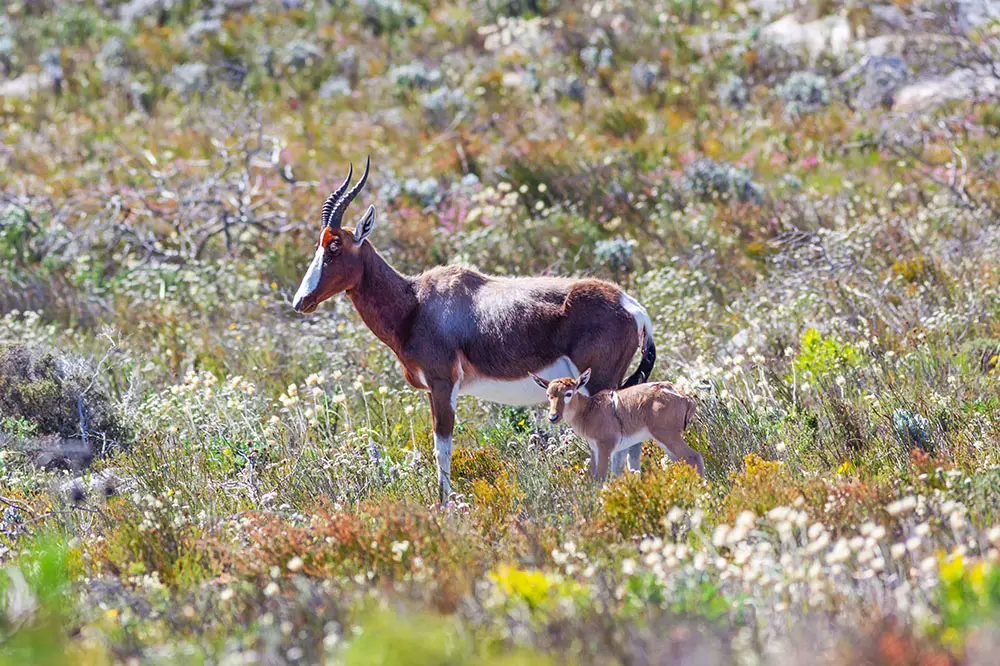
532;369;705;479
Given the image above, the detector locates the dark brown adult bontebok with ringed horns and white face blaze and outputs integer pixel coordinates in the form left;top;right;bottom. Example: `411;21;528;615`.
293;156;656;501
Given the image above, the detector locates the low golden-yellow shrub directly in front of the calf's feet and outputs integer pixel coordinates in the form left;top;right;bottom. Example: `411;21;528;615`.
601;463;709;538
